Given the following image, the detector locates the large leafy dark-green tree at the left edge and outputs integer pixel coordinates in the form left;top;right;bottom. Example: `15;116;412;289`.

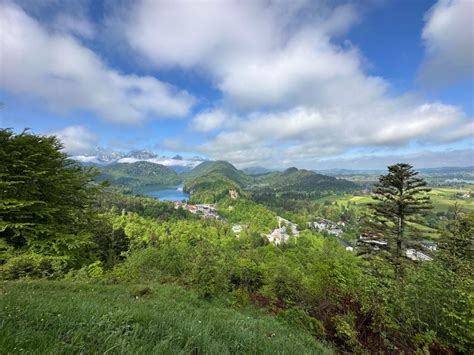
0;129;97;263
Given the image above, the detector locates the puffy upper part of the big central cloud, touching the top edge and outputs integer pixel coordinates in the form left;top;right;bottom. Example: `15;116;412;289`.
123;0;366;108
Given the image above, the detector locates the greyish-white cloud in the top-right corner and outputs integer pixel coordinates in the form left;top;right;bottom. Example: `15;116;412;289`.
421;0;474;85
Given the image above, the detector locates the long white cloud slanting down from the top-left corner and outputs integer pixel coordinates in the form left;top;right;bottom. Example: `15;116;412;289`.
0;2;194;123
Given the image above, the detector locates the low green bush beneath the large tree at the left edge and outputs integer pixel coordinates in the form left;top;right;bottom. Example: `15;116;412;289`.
0;253;67;280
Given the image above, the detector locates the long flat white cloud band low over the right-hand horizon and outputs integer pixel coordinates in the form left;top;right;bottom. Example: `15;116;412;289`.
199;103;474;165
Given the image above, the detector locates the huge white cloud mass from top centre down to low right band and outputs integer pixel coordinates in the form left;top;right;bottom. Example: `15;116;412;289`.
116;0;473;168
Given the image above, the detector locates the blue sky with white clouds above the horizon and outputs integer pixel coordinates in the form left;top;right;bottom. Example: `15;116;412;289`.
0;0;474;169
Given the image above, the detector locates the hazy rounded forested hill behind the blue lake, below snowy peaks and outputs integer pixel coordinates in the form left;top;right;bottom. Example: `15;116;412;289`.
99;161;182;187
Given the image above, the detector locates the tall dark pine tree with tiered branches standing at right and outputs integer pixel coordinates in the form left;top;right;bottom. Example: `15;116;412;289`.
368;163;432;278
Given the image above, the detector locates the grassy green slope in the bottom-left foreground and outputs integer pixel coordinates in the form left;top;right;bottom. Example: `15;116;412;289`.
0;281;332;354
